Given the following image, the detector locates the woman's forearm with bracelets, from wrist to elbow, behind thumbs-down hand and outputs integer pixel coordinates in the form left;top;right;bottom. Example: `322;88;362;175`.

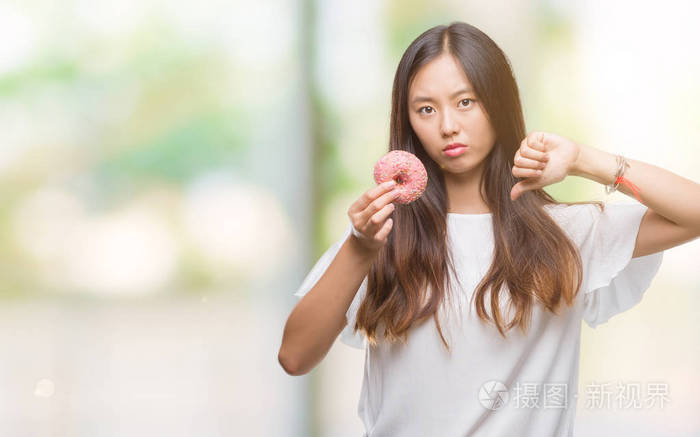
569;145;700;232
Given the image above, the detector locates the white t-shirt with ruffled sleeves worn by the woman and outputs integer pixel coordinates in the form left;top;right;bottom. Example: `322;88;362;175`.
295;203;663;437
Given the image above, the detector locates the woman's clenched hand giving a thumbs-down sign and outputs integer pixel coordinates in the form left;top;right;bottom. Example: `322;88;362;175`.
510;132;580;200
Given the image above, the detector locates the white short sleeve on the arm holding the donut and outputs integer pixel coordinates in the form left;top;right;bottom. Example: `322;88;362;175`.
294;224;367;349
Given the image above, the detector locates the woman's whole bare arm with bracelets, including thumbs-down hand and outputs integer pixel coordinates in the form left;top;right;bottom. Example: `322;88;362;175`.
511;131;700;258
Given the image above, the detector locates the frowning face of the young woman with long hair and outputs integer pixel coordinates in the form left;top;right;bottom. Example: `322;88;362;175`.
408;54;496;175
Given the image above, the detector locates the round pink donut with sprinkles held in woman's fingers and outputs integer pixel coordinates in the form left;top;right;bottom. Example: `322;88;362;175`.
374;150;428;204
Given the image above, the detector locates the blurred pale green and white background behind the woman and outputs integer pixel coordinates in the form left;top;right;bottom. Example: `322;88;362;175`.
0;0;700;436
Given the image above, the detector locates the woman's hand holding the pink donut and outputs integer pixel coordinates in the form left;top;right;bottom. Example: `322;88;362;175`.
348;180;398;252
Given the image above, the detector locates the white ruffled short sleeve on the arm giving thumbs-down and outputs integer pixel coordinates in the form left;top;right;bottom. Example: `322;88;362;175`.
580;203;663;328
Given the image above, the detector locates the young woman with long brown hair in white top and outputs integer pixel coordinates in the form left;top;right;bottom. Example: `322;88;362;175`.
279;22;700;437
